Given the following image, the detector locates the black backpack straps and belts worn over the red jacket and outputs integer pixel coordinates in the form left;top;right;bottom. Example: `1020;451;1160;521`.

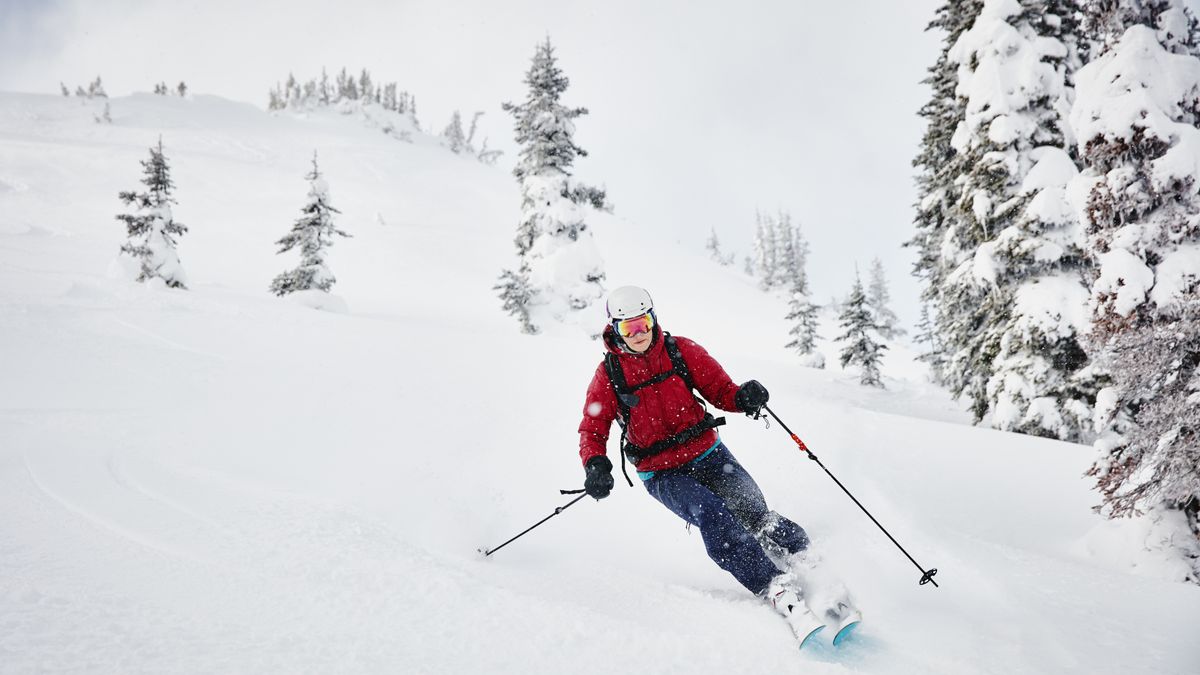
604;333;725;485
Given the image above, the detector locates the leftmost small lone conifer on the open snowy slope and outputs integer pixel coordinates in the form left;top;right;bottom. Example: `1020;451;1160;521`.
116;138;187;288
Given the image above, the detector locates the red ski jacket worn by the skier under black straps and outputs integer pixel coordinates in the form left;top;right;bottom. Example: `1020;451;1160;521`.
580;325;739;471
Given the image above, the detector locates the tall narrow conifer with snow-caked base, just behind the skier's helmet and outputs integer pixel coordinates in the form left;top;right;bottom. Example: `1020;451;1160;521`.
499;37;605;327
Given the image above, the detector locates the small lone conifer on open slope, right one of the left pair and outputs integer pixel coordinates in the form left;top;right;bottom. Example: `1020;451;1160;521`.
270;153;349;297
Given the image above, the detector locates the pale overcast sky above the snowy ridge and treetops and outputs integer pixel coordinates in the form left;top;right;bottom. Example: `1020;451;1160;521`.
9;0;1176;323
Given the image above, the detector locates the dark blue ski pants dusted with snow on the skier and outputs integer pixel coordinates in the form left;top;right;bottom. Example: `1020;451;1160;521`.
643;441;809;593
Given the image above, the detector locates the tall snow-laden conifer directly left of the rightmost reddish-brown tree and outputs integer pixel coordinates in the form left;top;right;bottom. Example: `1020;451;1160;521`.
938;0;1097;441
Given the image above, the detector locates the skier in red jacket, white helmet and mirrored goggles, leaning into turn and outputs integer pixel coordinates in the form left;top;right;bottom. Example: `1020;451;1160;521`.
580;286;847;646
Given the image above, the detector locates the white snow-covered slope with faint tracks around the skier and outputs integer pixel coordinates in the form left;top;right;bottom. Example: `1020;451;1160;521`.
0;94;1200;674
